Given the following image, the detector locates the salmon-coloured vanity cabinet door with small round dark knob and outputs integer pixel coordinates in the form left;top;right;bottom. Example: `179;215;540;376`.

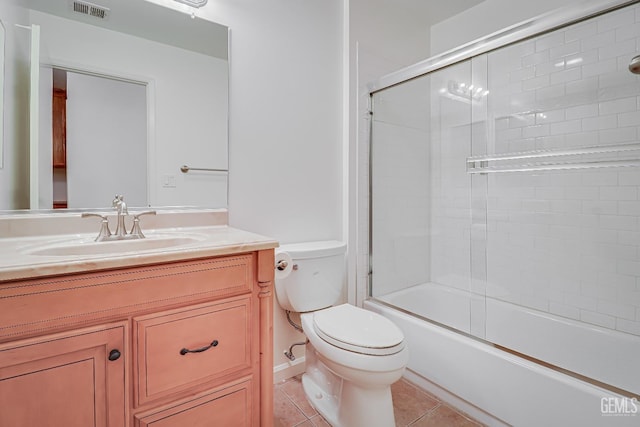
0;324;127;427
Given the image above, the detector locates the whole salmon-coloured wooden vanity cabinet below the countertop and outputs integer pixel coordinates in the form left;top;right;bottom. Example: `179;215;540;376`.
0;249;274;427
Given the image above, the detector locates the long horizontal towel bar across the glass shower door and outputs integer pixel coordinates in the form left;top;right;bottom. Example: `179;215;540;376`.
467;142;640;174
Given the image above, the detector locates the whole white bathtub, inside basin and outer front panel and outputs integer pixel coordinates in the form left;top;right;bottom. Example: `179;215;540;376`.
364;283;640;426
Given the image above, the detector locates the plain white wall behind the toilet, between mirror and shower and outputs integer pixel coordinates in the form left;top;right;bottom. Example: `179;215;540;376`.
148;0;344;372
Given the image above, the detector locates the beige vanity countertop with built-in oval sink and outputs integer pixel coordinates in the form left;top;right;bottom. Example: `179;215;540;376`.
0;212;278;283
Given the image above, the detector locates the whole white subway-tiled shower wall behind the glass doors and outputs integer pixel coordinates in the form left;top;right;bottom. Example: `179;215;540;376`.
358;0;640;335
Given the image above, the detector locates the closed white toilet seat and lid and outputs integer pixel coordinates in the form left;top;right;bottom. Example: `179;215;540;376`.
313;304;404;356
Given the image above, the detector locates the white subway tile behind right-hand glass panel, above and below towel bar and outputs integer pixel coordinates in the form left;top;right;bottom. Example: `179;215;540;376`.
487;5;640;335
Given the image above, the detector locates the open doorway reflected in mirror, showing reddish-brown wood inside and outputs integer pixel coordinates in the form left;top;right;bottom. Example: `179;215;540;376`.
41;68;148;208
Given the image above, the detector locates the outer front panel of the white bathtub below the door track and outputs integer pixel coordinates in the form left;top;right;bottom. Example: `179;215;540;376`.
364;301;640;427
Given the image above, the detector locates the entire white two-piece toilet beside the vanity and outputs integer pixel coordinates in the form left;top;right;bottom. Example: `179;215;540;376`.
275;241;409;427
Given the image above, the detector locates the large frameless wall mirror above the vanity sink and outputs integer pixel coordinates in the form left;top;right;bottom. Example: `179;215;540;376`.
0;0;229;210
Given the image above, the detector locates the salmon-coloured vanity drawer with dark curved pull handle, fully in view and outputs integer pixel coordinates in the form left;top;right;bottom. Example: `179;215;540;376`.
133;296;251;405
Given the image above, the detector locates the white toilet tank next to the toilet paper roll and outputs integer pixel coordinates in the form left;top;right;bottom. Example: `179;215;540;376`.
275;240;347;313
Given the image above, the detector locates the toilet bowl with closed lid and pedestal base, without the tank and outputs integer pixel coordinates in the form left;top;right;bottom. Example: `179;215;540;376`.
301;304;409;427
